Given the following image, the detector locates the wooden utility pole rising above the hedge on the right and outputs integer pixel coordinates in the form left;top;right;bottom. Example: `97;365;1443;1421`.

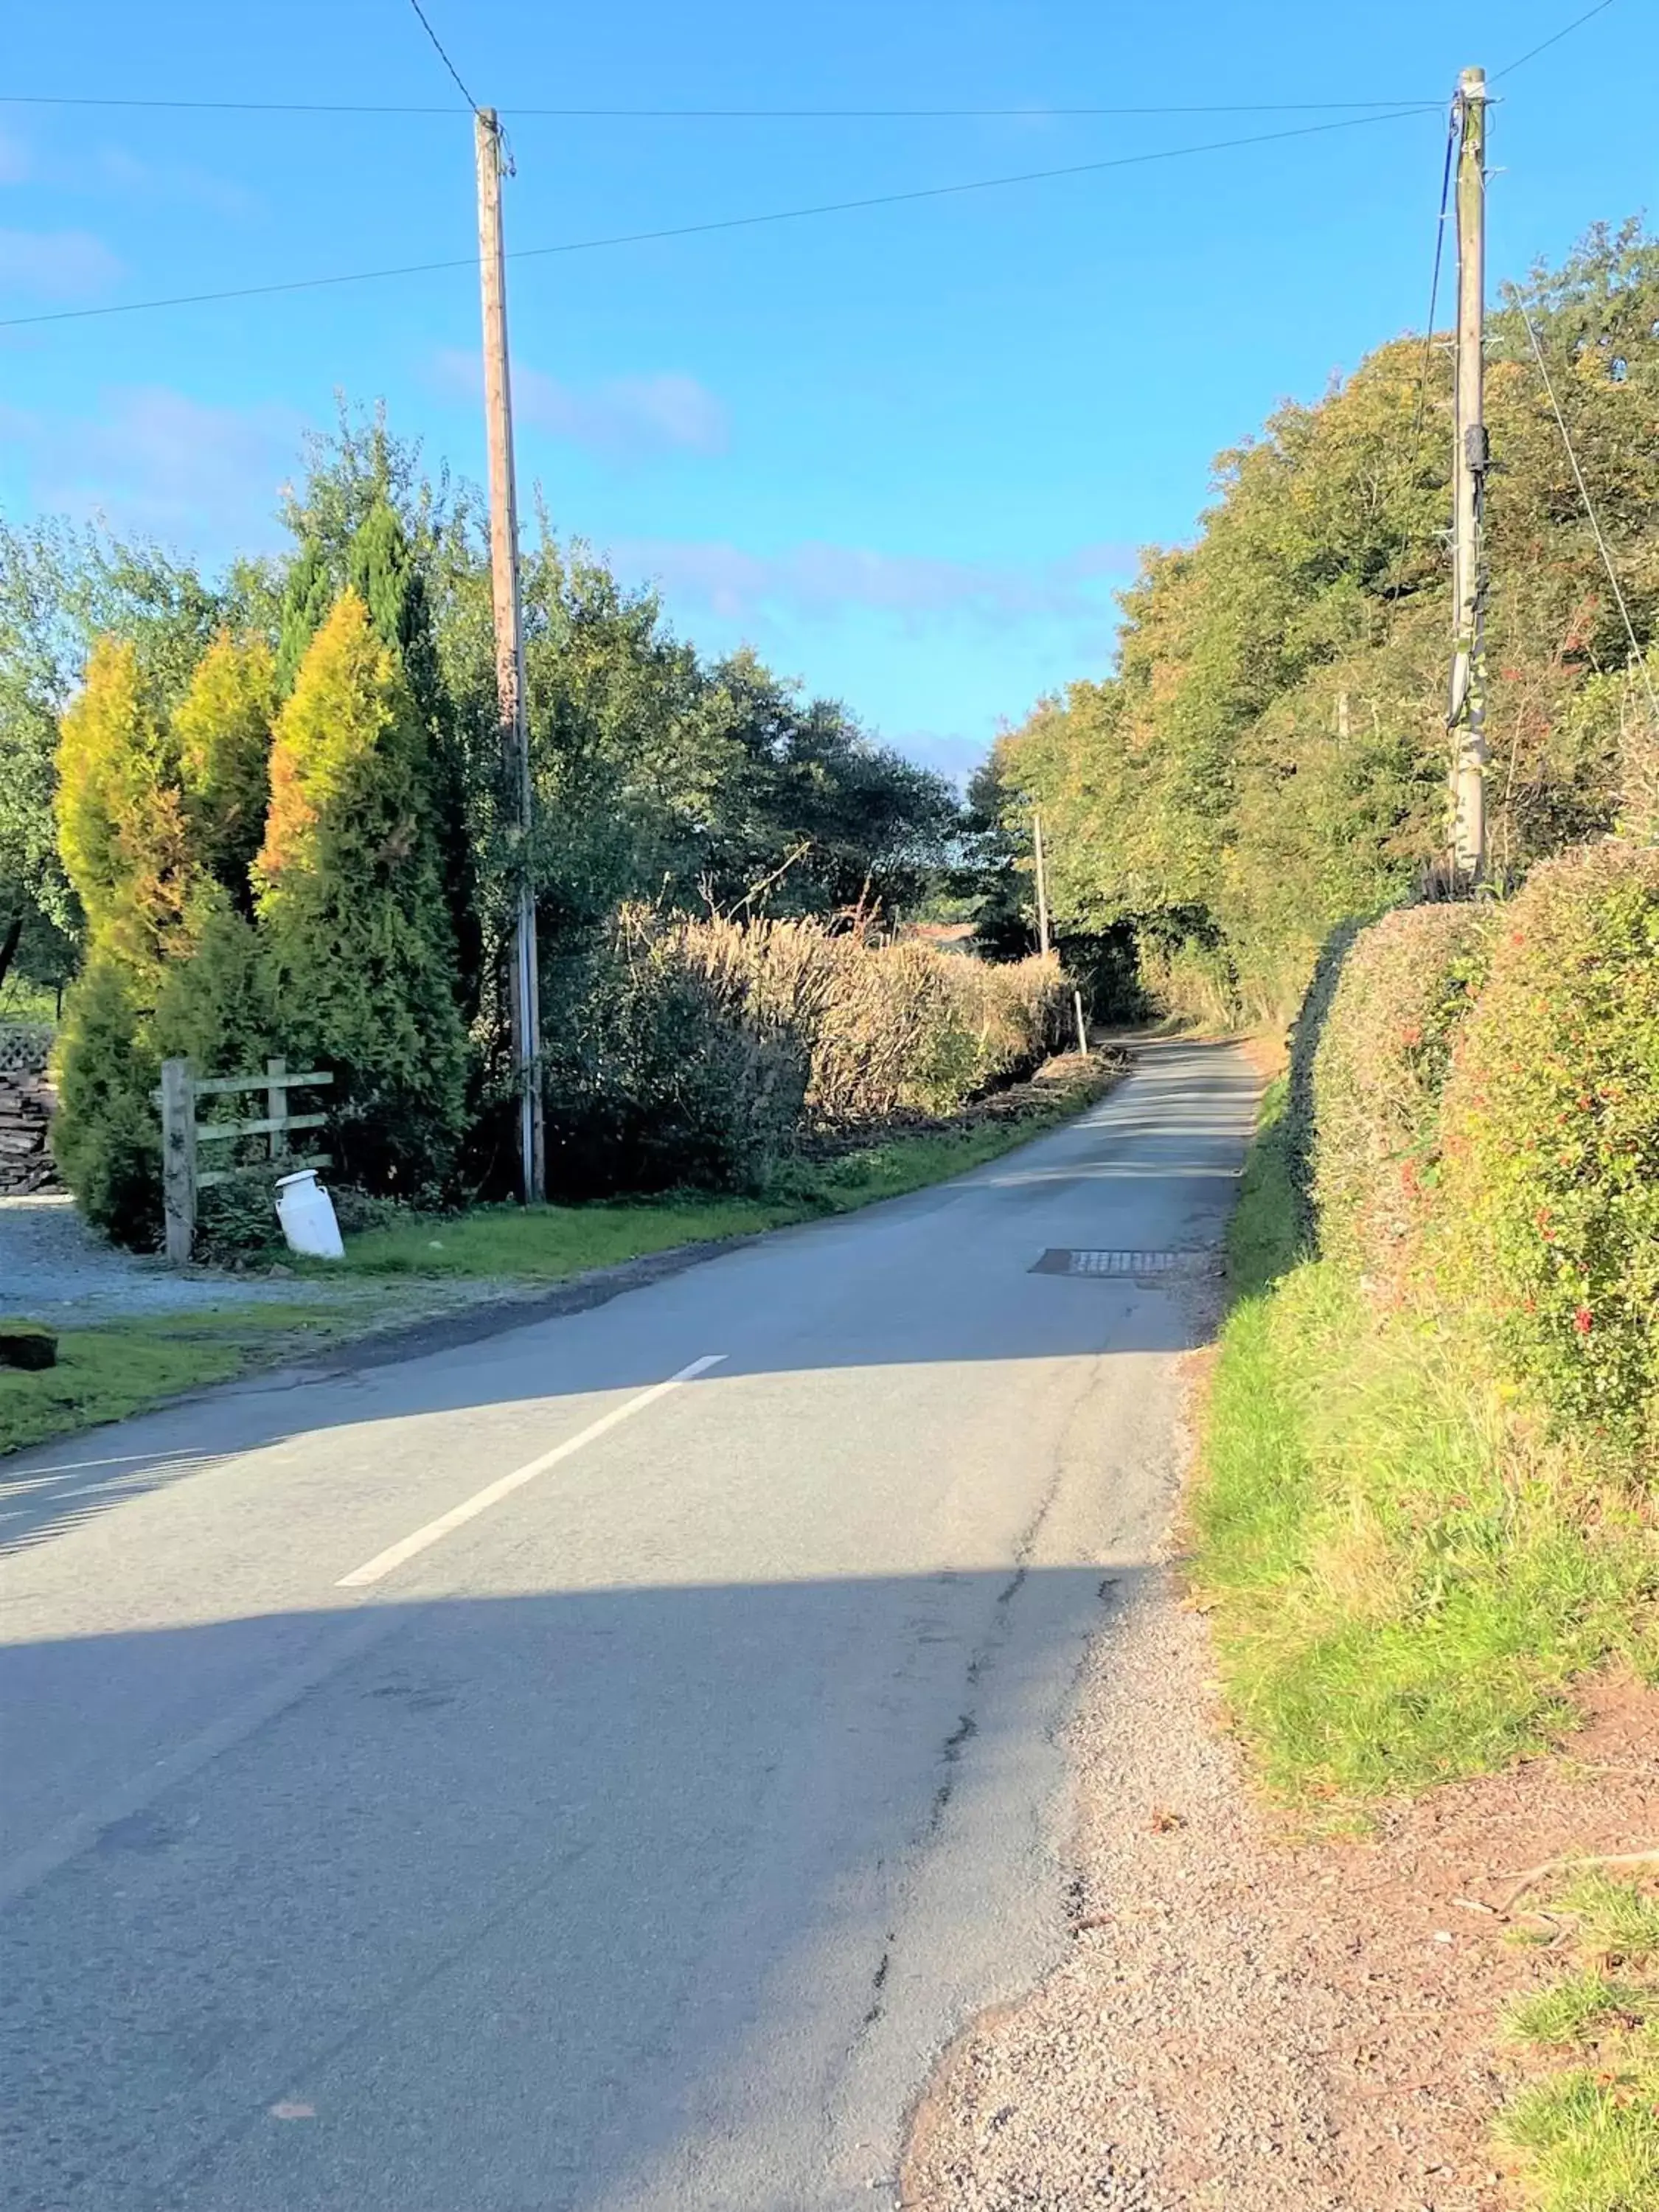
1447;69;1486;889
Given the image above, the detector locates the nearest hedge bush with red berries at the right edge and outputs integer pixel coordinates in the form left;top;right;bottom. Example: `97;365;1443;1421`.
1440;841;1659;1425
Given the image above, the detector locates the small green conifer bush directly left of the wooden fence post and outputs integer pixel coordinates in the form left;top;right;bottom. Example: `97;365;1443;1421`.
51;949;161;1252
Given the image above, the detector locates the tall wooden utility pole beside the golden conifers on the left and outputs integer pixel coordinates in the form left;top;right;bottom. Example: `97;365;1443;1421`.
473;108;546;1206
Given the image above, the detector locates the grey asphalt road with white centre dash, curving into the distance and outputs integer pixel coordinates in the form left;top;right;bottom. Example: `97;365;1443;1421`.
0;1044;1256;2212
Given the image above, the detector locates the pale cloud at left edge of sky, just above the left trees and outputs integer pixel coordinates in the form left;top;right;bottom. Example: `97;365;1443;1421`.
0;385;305;553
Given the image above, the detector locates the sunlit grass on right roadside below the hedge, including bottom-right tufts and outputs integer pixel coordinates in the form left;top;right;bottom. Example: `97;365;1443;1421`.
1192;1086;1659;2212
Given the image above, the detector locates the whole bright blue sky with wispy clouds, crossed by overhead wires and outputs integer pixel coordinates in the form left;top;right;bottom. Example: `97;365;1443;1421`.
0;0;1659;772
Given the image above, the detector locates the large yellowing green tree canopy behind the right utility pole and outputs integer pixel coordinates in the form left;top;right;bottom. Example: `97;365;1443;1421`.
995;223;1659;1011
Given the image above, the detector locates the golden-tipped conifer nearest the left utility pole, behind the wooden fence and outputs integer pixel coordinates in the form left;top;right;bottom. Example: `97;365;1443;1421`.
254;588;467;1190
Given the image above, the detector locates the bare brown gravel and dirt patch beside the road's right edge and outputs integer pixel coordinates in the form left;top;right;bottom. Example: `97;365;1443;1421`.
900;1573;1659;2212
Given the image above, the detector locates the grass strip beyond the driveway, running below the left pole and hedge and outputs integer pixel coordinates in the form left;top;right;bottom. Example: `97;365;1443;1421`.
325;1077;1119;1283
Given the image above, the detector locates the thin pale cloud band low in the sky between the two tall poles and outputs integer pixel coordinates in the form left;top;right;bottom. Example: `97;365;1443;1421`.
611;538;1135;628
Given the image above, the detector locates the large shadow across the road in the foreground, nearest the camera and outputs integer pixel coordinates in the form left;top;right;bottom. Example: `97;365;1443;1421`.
0;1566;1137;2212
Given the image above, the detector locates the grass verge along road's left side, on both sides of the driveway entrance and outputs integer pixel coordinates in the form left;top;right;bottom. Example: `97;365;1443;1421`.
0;1064;1119;1453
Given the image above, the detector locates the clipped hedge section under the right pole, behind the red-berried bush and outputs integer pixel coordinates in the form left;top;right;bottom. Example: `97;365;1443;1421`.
1312;905;1493;1285
